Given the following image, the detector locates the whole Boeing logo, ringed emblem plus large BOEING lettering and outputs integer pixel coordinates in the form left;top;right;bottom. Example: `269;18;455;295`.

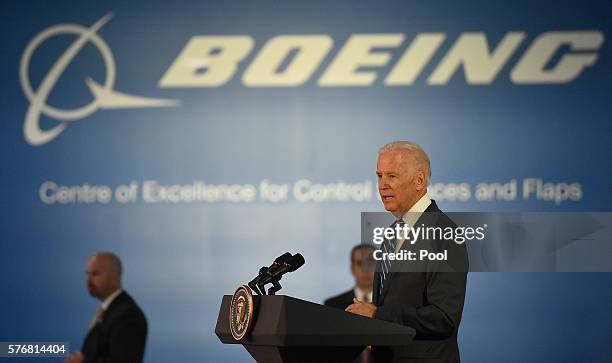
20;14;604;145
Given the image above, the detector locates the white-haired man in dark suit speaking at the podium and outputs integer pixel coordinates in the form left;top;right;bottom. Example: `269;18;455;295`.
346;141;468;363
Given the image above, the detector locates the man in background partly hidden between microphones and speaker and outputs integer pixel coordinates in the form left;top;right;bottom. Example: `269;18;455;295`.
323;244;374;310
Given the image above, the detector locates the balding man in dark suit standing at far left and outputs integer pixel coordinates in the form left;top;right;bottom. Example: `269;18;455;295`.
66;253;147;363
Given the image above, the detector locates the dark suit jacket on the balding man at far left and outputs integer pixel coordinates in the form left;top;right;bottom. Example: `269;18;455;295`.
81;291;147;363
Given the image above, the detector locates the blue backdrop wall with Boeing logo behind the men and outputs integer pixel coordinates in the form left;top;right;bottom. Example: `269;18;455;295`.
0;1;612;363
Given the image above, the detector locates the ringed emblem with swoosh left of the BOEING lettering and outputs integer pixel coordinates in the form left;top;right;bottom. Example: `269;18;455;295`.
19;14;179;146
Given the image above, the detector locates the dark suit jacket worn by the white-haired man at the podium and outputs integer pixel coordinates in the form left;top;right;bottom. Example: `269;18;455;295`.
373;200;468;363
